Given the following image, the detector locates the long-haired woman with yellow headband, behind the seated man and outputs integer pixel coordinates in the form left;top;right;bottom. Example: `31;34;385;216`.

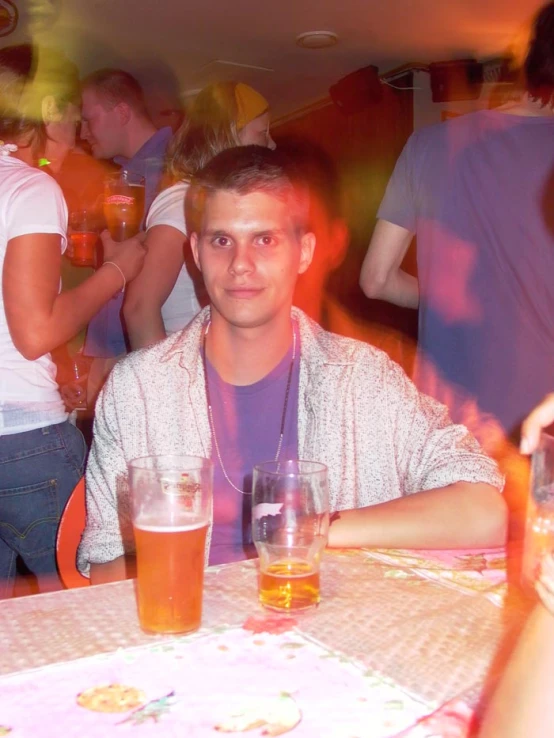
123;82;275;349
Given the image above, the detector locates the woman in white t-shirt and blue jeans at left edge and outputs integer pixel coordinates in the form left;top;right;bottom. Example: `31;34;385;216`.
0;45;144;598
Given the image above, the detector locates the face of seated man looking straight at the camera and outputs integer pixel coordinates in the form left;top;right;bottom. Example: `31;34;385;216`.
191;191;315;328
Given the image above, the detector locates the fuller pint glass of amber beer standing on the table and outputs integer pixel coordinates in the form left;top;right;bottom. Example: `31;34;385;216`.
129;456;213;633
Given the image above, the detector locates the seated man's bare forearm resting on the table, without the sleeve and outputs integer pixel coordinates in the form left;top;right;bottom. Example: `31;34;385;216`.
329;482;507;548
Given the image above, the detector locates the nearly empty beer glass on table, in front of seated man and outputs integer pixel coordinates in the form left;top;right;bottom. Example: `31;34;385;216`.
252;459;329;611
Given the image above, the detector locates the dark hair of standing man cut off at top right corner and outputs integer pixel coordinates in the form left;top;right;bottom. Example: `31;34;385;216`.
524;2;554;105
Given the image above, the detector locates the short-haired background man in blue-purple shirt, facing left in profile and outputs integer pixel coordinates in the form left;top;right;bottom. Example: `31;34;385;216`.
81;68;172;402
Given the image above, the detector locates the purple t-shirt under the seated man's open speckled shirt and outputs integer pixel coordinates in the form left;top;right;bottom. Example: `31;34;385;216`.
206;330;300;564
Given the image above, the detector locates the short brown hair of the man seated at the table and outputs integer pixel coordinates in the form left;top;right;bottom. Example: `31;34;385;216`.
186;145;309;235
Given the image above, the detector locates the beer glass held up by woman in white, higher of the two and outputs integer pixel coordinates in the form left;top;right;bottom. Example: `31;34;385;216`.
104;170;144;241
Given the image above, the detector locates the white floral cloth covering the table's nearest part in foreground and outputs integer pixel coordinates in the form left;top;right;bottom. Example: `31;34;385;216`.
0;619;461;738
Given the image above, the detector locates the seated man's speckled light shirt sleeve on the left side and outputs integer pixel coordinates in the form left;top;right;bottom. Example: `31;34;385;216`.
77;365;134;576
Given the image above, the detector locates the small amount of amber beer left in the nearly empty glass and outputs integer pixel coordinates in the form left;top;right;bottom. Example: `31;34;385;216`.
259;559;320;610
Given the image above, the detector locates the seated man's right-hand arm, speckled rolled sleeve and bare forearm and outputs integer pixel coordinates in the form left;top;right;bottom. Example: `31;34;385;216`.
329;356;507;548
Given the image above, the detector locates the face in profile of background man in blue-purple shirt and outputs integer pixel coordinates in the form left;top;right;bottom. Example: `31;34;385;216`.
81;89;123;159
